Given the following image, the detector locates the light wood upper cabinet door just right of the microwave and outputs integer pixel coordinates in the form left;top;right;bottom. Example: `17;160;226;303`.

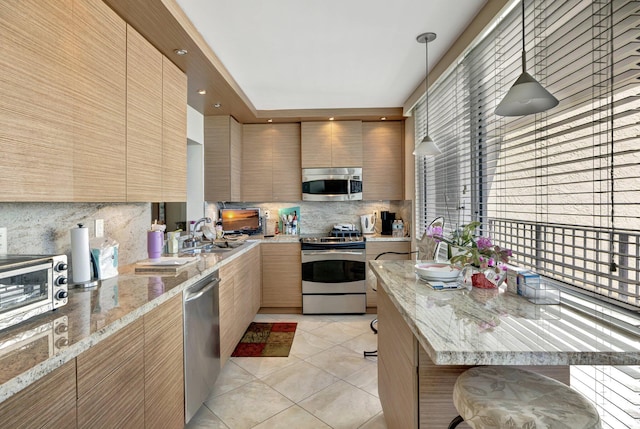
362;121;404;200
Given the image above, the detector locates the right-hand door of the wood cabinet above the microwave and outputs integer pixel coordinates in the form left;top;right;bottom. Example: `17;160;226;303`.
331;121;362;167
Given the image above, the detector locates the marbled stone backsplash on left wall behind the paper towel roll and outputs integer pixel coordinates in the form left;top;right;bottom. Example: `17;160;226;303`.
0;203;151;265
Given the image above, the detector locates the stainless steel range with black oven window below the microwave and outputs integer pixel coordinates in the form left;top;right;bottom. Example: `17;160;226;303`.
300;228;367;314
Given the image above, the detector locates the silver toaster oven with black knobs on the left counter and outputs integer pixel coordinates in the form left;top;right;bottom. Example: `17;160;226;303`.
0;255;68;330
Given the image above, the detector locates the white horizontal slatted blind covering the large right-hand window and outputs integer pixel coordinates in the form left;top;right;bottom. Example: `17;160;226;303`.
413;0;640;310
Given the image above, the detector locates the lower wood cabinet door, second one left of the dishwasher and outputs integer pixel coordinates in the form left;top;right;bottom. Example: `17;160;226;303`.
76;319;144;429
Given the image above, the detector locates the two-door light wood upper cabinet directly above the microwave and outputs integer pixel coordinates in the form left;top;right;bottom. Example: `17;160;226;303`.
301;121;362;168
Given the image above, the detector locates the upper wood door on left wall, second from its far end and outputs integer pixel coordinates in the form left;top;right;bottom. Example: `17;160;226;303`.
127;25;162;201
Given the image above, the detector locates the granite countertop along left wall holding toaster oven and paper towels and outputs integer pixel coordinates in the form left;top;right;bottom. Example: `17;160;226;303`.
0;240;260;402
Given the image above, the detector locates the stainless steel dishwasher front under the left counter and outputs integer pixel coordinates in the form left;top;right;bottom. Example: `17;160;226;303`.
182;271;220;423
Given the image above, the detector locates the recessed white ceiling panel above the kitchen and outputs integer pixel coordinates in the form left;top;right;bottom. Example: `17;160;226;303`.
177;0;487;110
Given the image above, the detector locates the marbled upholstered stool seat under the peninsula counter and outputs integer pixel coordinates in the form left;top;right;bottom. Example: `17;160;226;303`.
449;366;601;429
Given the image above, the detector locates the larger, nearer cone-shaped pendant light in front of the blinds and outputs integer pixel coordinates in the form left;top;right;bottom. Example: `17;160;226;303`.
496;0;558;116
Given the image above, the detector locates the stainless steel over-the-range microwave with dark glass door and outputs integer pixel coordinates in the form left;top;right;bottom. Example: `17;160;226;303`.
302;168;362;201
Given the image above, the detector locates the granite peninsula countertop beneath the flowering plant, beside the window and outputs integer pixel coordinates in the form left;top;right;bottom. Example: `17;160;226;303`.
369;260;640;365
